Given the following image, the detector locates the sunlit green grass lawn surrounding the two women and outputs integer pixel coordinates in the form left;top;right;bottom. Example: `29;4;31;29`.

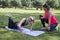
0;8;60;40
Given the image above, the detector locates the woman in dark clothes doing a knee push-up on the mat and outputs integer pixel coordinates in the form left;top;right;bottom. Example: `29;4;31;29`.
8;16;34;32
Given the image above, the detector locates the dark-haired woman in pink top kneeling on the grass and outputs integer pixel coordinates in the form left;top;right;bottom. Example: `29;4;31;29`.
39;4;58;31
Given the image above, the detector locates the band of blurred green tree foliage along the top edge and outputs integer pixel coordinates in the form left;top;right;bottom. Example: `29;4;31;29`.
0;0;60;9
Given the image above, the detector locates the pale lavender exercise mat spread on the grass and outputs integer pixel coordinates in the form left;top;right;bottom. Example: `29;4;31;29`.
5;26;45;36
